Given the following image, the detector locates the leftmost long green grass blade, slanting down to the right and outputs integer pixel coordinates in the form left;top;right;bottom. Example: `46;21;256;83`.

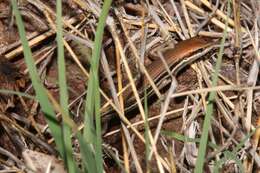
11;0;65;158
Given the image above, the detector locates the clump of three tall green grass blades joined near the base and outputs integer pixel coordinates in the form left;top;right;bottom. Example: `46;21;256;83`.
11;0;111;173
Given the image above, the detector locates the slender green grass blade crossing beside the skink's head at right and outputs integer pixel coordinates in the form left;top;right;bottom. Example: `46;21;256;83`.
194;0;230;173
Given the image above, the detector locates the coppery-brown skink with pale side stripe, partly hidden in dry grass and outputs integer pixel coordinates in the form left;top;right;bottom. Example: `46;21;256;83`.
103;36;216;128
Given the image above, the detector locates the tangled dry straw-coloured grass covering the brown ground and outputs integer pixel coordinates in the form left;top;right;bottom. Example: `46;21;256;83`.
0;0;260;173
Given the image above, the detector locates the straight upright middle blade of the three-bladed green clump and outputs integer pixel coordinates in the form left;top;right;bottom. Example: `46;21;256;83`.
56;0;76;173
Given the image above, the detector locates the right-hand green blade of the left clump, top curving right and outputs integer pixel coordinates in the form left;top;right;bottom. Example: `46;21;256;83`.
83;0;112;172
